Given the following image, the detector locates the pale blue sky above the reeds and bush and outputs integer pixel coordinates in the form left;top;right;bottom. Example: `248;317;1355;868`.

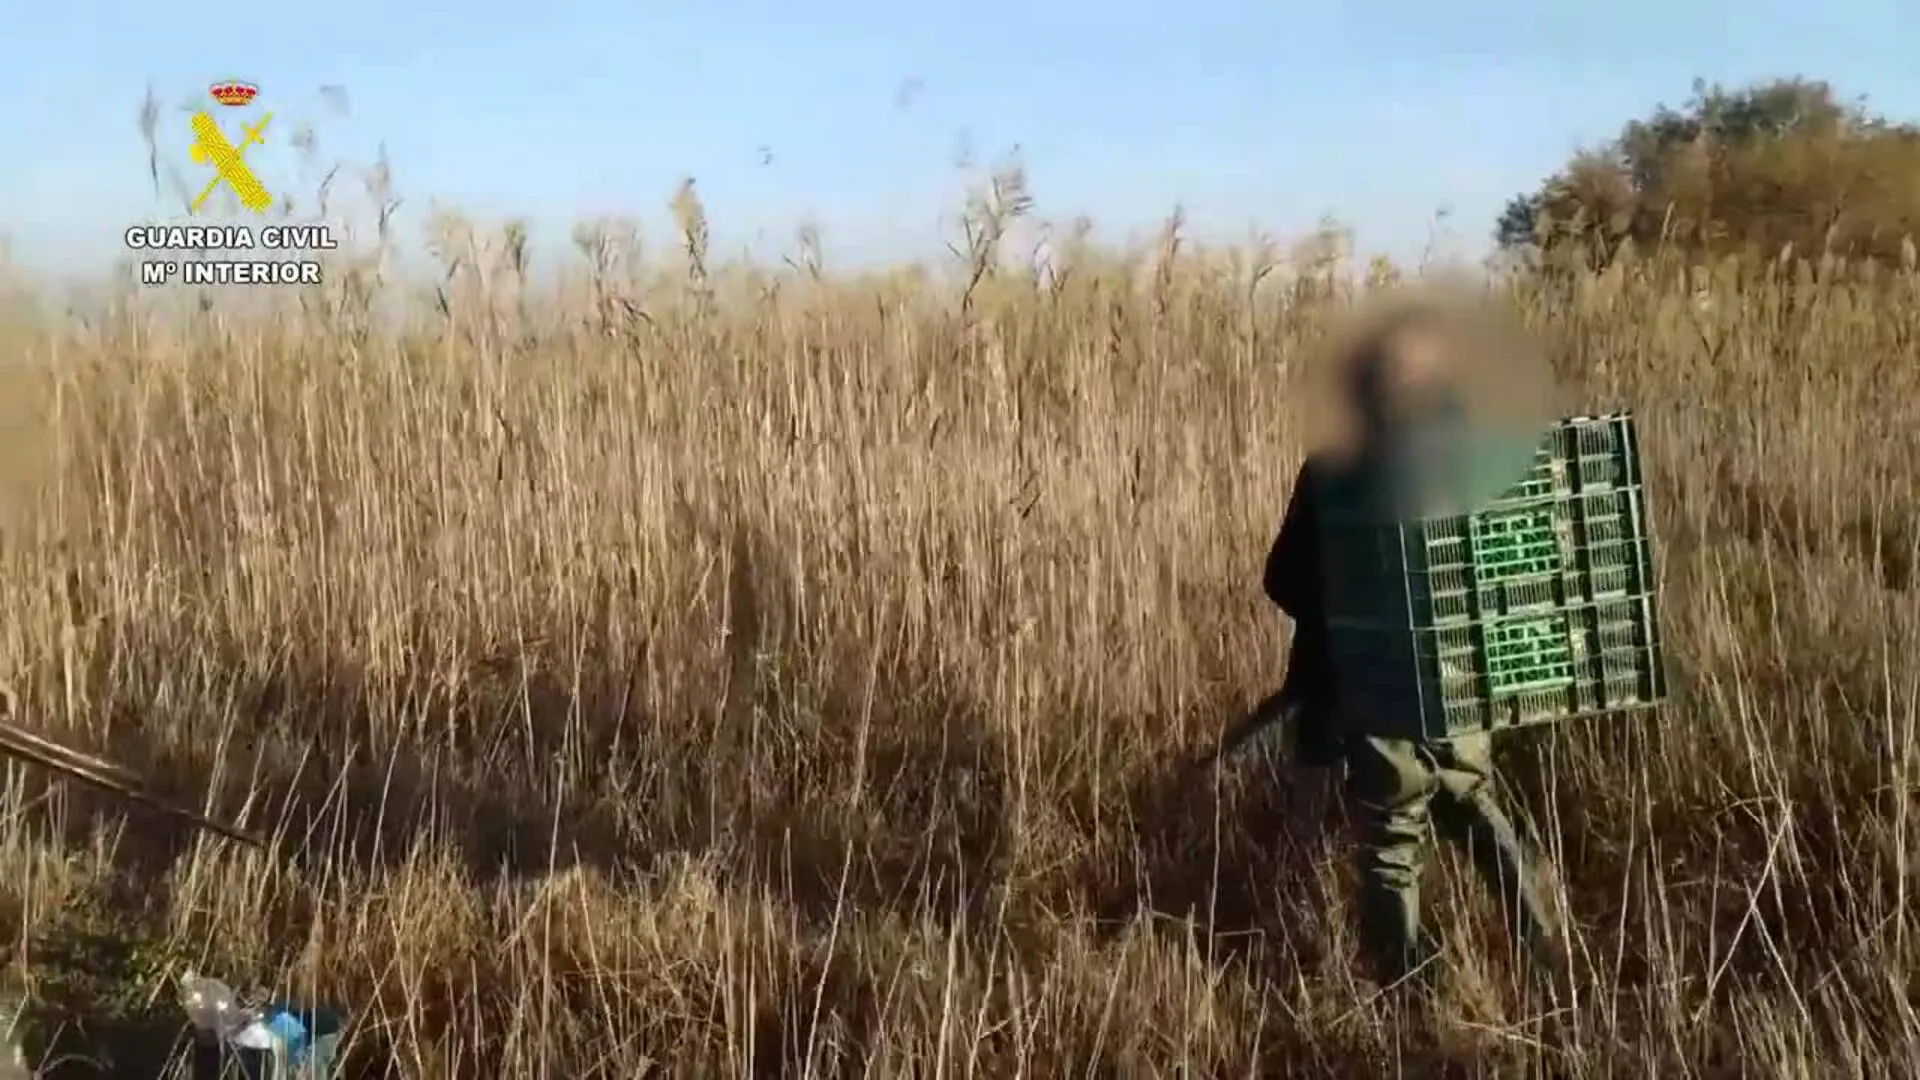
0;0;1920;269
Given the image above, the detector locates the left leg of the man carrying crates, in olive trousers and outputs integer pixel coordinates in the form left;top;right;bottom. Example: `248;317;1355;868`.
1346;738;1436;986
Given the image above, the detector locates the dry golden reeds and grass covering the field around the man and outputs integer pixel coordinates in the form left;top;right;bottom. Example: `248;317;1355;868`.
0;214;1920;1078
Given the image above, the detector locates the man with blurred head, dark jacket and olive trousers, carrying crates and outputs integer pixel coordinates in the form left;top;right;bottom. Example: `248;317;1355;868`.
1263;299;1565;990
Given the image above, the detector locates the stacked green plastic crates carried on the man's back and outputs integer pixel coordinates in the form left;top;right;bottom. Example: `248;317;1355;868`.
1321;413;1667;738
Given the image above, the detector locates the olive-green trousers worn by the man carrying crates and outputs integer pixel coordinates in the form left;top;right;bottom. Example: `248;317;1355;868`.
1346;734;1565;988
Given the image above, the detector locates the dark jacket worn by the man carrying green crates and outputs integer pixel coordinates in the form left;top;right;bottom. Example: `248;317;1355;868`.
1263;459;1344;765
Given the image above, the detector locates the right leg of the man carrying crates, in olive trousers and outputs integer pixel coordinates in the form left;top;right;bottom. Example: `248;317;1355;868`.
1432;734;1569;994
